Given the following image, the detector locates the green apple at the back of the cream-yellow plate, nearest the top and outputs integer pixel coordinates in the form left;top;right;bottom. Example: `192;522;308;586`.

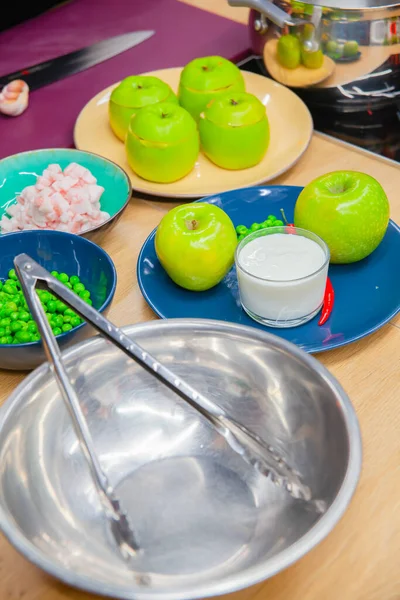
178;56;245;121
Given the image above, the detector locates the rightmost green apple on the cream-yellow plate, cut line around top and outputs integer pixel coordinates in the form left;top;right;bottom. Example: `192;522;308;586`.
199;92;269;170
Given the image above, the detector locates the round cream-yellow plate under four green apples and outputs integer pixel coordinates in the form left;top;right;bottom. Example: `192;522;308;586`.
74;68;313;198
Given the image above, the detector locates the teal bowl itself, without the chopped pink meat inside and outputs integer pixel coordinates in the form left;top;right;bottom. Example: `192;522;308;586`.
0;148;132;243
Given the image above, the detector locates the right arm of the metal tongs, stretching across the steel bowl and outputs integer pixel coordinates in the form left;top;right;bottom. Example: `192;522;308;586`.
14;254;310;500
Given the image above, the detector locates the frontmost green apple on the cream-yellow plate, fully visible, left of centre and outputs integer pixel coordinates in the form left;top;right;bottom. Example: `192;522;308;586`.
125;102;200;183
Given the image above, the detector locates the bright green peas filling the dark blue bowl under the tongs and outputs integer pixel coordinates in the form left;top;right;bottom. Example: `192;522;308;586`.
0;269;92;344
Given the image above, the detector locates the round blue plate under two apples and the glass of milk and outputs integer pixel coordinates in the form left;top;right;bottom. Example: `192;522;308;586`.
137;185;400;352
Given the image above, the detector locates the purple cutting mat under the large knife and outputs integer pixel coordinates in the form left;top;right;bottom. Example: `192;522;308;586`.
0;0;249;158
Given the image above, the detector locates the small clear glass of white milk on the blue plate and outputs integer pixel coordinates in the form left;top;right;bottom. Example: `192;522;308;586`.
235;227;330;327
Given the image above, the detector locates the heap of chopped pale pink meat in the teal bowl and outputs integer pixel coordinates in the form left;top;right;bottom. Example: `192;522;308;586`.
0;163;110;233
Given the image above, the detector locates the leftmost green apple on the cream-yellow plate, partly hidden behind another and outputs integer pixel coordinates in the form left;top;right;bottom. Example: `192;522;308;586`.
108;75;178;142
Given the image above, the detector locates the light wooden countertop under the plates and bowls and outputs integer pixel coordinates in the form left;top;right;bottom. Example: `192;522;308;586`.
0;0;400;600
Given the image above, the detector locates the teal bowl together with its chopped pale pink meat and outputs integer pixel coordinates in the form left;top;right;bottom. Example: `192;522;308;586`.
0;148;132;243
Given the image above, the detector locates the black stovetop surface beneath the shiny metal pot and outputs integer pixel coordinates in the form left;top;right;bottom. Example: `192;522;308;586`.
238;55;400;162
